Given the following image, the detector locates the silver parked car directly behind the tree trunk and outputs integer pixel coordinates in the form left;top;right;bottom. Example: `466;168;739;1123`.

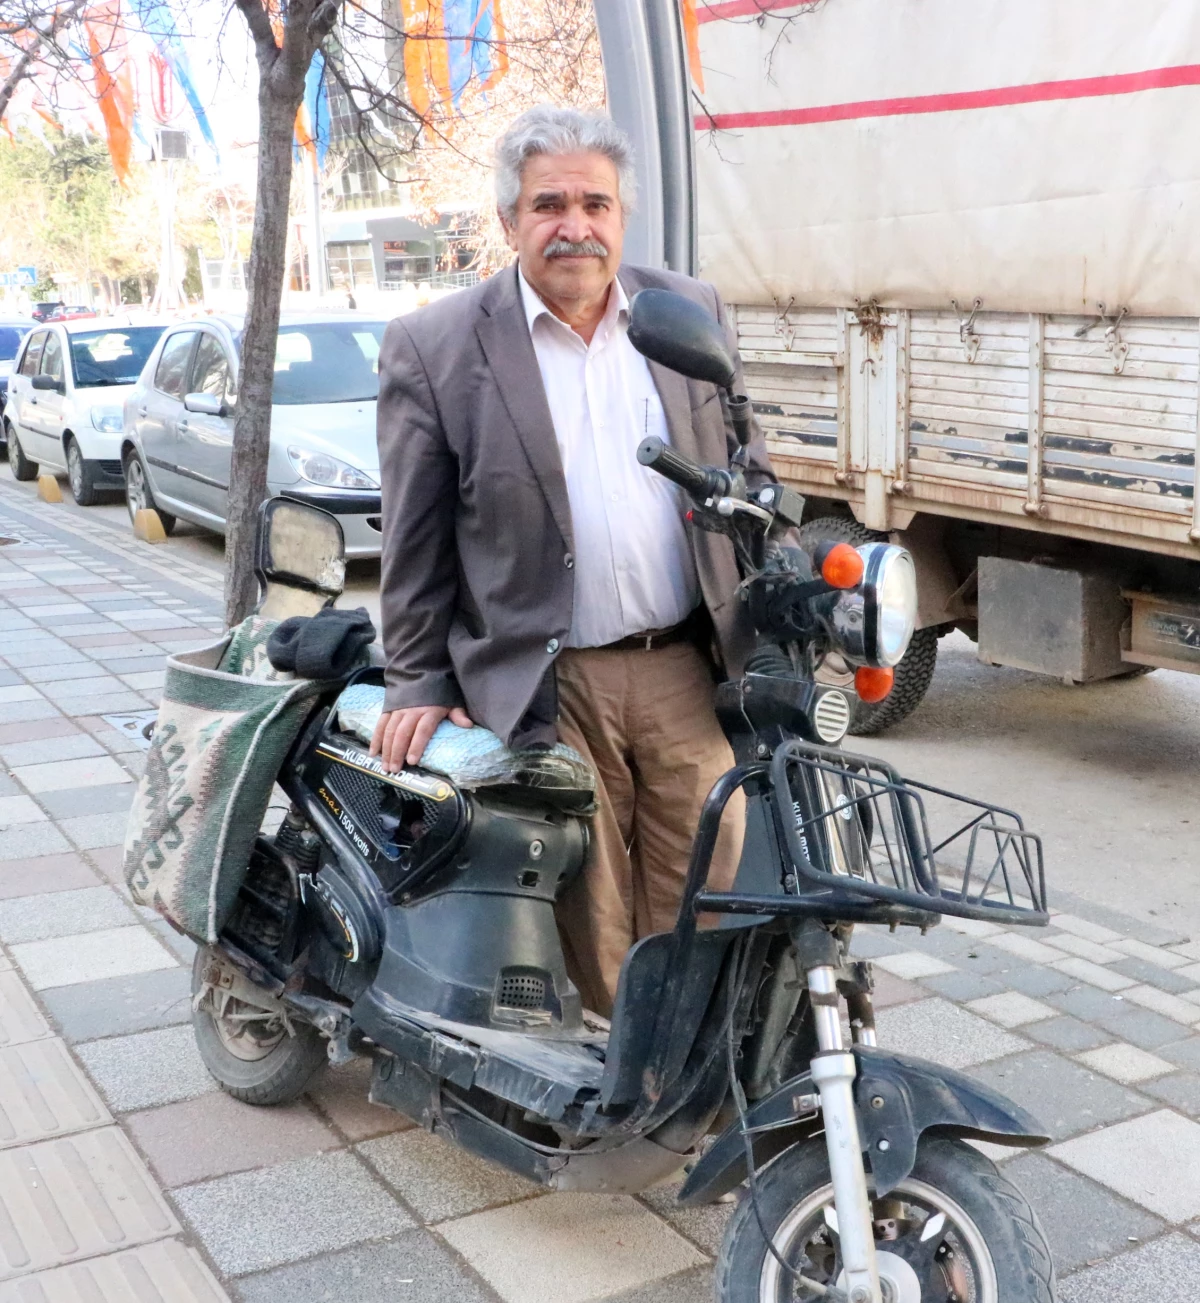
121;313;387;556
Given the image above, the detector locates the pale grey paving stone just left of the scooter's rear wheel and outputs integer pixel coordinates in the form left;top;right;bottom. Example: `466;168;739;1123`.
76;1023;216;1113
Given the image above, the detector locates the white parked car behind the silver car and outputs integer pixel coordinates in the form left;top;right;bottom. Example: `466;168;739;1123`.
4;322;164;507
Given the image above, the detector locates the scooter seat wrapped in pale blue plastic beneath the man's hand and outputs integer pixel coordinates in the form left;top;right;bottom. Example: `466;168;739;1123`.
336;683;595;808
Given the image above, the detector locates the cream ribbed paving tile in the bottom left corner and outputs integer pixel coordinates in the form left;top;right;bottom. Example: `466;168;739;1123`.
0;1239;228;1303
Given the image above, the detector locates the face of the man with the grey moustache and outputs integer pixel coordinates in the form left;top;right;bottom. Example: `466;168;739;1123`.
504;154;625;305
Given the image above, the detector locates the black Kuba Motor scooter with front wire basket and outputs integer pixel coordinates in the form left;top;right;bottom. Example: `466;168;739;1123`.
193;291;1055;1303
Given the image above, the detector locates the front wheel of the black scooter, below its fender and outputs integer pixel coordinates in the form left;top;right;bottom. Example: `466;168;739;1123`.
717;1138;1057;1303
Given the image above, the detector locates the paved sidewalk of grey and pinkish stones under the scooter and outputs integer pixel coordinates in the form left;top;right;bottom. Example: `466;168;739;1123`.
0;474;1200;1303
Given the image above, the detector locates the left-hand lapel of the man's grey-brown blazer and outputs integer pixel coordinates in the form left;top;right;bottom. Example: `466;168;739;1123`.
476;265;572;546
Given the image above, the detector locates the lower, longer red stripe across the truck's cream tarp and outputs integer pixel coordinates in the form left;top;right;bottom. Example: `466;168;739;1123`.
696;64;1200;132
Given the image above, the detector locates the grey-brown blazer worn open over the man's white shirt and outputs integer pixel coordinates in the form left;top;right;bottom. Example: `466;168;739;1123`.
378;266;774;745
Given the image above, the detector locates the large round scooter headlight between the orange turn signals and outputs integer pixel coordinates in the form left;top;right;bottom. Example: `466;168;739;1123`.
830;543;917;667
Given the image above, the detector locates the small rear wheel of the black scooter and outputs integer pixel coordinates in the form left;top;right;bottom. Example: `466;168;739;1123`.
192;947;327;1105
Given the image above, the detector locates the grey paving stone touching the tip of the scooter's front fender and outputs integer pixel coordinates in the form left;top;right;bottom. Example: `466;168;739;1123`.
969;1049;1153;1140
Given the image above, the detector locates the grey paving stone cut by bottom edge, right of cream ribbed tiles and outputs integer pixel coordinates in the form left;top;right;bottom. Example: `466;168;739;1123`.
231;1230;495;1303
